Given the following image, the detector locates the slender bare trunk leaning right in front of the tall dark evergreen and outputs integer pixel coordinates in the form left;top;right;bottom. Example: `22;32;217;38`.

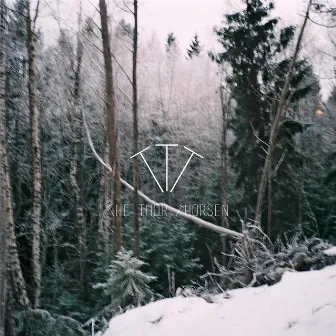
255;0;312;226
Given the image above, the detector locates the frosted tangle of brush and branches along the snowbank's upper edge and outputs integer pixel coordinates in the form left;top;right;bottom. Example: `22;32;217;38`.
206;225;336;291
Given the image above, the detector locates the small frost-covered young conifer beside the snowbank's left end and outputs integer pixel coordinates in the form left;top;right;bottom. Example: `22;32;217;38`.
94;249;155;311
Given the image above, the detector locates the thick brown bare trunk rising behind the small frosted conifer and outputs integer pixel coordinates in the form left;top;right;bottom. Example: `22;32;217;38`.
99;0;121;254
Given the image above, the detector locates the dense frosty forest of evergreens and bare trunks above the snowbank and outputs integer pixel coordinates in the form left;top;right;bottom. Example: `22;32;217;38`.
0;0;336;336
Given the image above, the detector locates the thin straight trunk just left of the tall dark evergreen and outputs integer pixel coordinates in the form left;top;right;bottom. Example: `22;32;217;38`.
220;84;229;266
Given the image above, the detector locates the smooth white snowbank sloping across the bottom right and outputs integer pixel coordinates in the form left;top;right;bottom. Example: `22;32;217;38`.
103;265;336;336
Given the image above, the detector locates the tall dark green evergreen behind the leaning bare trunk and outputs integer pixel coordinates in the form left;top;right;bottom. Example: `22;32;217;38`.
210;0;311;235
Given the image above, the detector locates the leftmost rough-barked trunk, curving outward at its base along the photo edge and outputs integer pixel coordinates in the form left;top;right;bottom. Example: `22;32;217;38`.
0;0;29;307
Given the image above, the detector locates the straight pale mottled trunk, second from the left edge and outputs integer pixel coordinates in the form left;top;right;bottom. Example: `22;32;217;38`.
27;0;42;308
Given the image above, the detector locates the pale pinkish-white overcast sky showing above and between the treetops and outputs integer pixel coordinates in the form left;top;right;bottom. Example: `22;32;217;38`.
33;0;336;96
